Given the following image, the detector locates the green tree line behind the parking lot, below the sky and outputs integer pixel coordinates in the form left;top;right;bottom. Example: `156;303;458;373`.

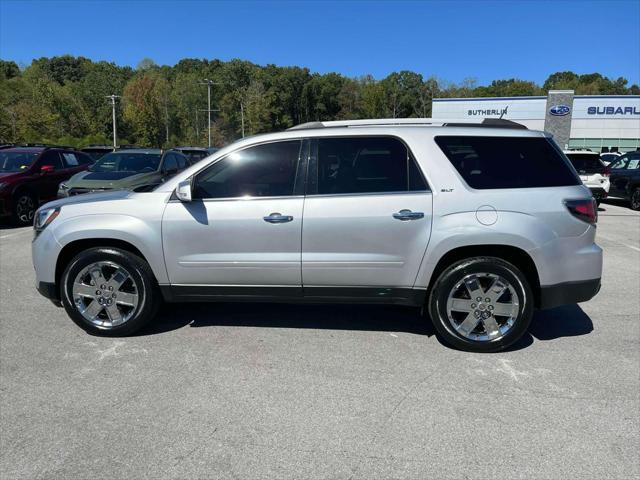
0;55;640;147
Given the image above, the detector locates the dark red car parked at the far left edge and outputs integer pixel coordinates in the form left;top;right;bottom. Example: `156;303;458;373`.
0;146;93;225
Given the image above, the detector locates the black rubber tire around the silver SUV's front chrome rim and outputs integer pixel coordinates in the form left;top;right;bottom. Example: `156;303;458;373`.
60;247;160;336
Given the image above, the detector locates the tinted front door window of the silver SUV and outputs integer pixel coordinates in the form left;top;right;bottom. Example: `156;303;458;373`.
194;140;301;198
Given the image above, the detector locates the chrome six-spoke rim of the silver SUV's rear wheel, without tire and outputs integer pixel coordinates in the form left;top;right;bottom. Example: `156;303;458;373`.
447;273;520;342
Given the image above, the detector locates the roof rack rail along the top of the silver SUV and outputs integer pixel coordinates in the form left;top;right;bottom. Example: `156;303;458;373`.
287;118;527;130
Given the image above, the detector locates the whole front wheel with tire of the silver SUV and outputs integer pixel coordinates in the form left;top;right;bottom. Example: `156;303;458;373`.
61;248;160;335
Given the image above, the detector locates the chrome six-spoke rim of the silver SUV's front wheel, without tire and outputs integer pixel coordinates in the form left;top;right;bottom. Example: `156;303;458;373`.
72;262;139;329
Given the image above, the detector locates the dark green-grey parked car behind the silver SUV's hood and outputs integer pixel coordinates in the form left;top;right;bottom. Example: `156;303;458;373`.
58;148;190;198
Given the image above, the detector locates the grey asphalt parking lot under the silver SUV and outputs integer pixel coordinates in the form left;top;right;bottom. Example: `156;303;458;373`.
0;202;640;480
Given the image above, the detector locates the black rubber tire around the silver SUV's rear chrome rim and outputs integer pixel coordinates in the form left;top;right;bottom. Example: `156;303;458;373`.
428;257;534;352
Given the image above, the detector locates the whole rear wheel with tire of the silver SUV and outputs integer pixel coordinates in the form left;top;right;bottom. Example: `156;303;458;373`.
429;257;533;352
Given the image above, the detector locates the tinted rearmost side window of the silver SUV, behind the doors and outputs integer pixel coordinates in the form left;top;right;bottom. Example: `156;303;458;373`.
435;136;580;189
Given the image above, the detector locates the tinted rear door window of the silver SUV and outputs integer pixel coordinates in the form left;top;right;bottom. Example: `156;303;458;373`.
318;137;426;194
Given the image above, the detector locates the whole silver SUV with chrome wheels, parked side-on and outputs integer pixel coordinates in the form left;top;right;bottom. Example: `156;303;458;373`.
33;119;602;351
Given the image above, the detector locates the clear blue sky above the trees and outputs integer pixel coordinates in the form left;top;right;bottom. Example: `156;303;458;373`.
0;0;640;85
